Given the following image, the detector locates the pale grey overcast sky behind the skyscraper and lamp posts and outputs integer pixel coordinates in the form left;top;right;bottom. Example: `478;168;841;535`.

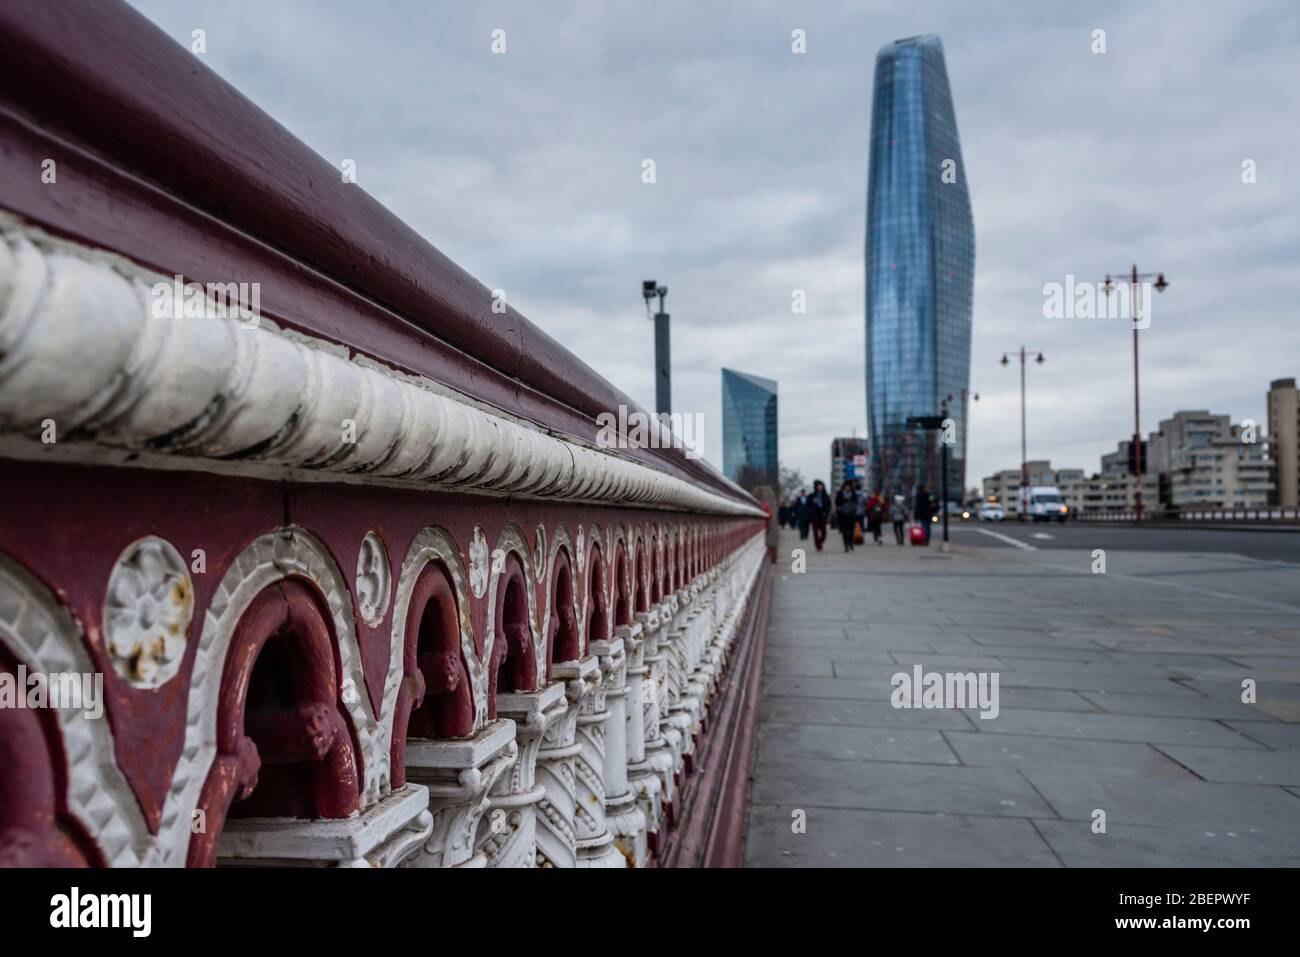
133;0;1300;484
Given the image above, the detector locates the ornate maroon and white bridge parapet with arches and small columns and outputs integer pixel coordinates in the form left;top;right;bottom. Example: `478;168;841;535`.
0;0;768;867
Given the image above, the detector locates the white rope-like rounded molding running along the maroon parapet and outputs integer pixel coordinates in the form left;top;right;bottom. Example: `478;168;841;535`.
0;223;763;520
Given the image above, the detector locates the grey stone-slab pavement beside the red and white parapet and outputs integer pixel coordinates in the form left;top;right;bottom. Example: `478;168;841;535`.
745;532;1300;867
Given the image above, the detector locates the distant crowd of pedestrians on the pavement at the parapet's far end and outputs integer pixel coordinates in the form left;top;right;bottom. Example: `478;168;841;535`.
777;479;939;551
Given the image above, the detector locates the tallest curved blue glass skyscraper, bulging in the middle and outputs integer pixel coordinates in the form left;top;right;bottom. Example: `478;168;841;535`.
866;34;975;501
